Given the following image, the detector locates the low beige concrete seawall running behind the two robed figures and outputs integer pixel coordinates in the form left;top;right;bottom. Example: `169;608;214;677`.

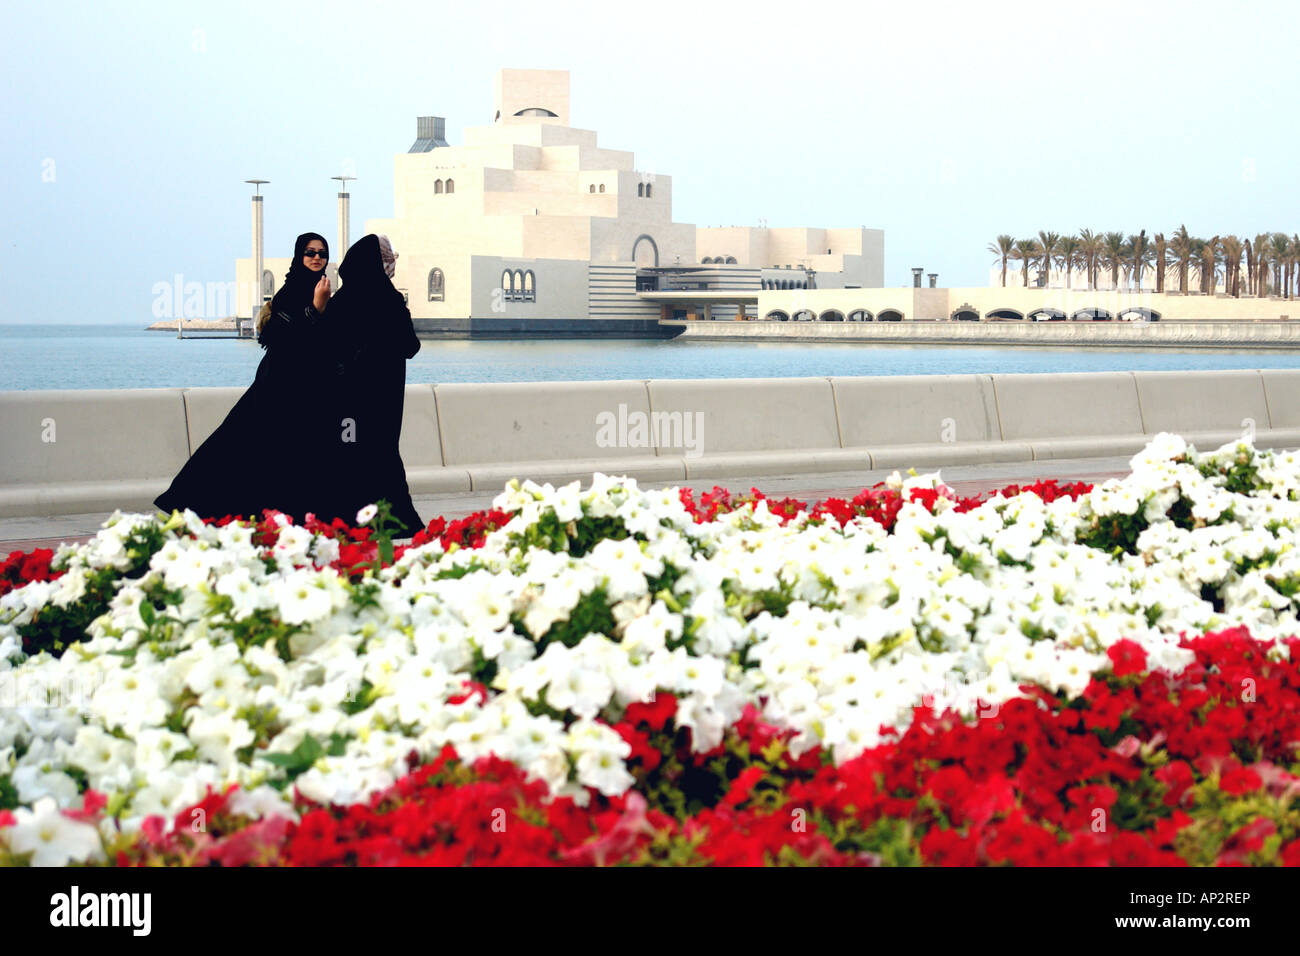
0;369;1300;516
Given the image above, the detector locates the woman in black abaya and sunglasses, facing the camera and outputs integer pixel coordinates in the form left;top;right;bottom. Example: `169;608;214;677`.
153;233;335;520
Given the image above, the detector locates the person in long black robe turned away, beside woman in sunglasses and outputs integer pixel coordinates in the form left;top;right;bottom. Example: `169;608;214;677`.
325;234;424;537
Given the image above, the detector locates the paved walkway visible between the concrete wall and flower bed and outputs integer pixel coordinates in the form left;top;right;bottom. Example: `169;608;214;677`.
0;458;1128;557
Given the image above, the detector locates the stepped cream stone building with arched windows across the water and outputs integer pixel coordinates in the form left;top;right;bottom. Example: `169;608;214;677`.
237;70;884;334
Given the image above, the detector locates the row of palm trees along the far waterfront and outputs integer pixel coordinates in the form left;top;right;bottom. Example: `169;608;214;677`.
988;225;1300;299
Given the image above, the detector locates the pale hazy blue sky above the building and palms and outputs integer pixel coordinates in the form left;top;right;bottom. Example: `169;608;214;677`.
0;0;1300;323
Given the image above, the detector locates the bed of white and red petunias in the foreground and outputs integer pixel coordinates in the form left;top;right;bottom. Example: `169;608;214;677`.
0;436;1300;864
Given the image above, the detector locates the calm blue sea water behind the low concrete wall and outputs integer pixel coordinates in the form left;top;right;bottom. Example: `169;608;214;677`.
0;325;1300;390
